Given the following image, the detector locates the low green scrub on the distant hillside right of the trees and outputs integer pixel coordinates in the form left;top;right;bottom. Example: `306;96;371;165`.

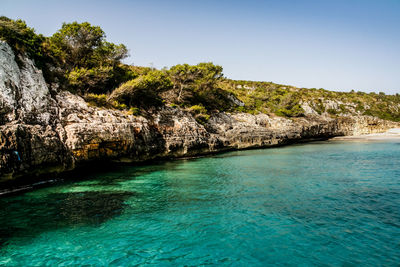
222;79;400;121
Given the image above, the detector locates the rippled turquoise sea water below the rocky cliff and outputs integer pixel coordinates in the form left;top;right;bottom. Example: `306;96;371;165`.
0;141;400;266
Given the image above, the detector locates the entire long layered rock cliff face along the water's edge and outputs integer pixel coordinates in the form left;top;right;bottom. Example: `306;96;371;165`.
0;42;399;184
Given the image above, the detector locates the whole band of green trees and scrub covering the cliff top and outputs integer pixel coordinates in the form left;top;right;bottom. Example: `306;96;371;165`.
0;17;400;123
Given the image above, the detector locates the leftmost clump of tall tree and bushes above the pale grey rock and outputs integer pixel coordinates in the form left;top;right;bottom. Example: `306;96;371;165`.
0;17;131;95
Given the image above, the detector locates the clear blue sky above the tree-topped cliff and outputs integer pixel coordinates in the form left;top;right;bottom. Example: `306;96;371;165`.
0;0;400;93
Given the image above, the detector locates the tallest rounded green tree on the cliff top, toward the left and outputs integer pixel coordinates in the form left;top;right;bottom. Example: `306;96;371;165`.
46;22;128;94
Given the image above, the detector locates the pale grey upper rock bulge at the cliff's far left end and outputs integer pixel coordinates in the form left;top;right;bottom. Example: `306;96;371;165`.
0;41;56;125
